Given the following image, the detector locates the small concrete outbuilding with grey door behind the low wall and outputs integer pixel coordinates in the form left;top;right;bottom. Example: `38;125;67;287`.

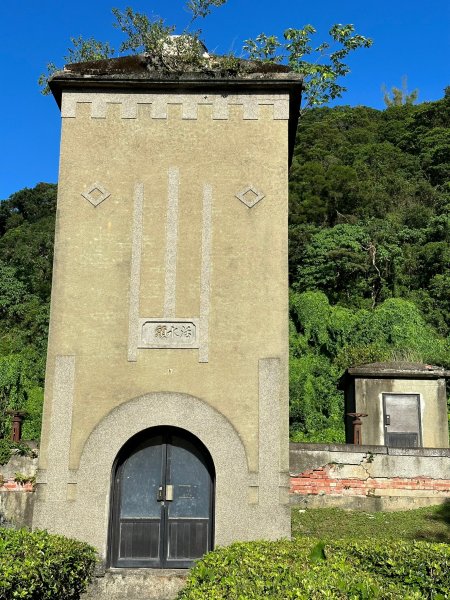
341;362;450;448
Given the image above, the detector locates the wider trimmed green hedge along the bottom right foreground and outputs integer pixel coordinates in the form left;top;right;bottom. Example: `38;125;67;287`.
177;538;450;600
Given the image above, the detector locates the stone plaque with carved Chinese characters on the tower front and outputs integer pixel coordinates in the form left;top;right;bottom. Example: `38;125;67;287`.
139;319;199;348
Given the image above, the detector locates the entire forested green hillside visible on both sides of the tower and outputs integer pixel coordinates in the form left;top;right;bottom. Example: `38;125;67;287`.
0;89;450;442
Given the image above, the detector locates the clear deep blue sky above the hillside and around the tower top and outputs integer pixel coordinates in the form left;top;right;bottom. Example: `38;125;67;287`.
0;0;450;199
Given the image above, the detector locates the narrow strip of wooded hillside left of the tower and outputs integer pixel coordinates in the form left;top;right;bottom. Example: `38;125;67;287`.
0;183;56;440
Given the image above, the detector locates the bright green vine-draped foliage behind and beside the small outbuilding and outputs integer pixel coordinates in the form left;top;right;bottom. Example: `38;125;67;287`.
290;291;450;442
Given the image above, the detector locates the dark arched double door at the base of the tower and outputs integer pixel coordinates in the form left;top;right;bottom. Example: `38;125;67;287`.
109;427;215;568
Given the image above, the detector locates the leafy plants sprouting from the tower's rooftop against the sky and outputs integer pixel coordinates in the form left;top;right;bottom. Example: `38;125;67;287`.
39;0;372;111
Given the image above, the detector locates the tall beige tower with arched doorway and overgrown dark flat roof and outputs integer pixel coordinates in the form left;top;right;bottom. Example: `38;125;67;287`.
33;55;302;569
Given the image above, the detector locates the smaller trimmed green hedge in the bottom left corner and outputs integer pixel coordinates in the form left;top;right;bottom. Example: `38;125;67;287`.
0;528;97;600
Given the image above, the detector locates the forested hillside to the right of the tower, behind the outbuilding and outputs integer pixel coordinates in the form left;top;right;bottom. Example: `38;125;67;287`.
289;88;450;441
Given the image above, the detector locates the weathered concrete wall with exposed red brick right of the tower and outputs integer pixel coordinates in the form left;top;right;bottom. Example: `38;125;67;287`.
290;444;450;510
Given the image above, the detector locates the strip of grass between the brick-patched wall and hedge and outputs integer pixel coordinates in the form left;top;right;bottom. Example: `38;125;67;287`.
292;502;450;544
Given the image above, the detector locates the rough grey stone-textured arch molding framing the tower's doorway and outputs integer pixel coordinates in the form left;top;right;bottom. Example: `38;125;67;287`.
72;392;251;556
